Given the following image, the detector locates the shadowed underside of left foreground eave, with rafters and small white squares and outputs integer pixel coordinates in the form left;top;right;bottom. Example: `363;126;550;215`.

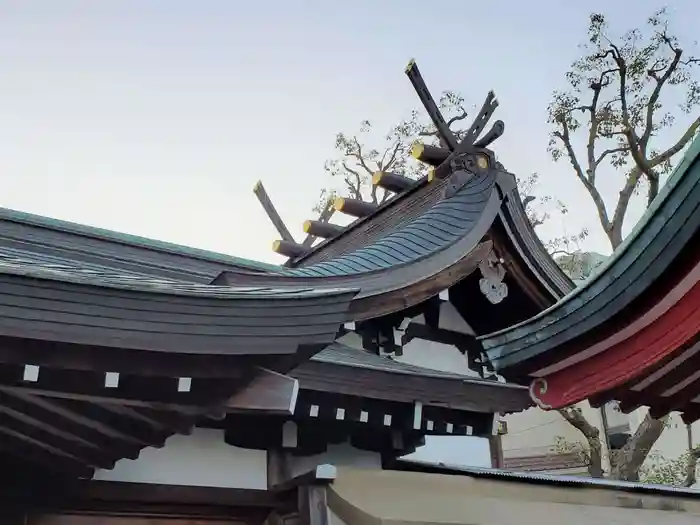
0;356;308;478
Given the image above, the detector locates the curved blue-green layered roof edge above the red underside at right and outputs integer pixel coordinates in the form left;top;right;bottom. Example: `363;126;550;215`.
481;133;700;379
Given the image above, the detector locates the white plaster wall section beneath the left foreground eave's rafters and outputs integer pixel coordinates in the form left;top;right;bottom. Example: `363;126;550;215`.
93;428;267;489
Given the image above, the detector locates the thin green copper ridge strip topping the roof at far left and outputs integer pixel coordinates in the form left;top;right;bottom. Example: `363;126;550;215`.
0;208;280;271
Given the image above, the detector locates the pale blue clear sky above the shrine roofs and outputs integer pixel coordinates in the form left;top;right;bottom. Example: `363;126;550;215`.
0;0;700;261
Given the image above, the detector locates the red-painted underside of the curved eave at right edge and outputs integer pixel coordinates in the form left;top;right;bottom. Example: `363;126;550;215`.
531;246;700;422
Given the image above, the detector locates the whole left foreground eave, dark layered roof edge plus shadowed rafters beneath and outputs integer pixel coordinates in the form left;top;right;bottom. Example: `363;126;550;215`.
0;255;355;477
